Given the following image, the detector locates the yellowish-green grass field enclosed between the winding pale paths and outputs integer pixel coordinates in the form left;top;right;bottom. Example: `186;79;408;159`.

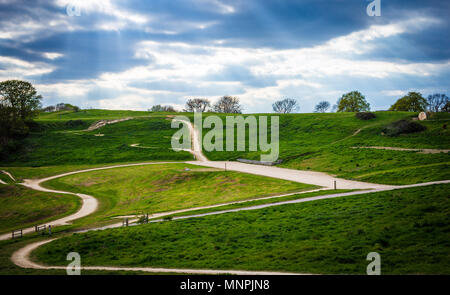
44;164;316;227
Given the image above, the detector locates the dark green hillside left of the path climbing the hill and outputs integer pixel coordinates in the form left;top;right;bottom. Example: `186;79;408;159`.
2;116;193;167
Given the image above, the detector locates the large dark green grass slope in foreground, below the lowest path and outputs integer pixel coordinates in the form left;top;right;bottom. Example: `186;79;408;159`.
33;184;450;274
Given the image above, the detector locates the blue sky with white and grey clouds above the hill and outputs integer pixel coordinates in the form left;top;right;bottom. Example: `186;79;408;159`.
0;0;450;113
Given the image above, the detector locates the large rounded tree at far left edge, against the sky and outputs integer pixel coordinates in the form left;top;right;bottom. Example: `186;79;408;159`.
0;80;42;122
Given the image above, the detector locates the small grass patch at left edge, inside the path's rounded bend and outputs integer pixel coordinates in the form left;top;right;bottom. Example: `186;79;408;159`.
0;185;81;233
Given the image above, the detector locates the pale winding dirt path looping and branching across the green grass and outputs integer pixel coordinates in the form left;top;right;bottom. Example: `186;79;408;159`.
7;119;450;275
